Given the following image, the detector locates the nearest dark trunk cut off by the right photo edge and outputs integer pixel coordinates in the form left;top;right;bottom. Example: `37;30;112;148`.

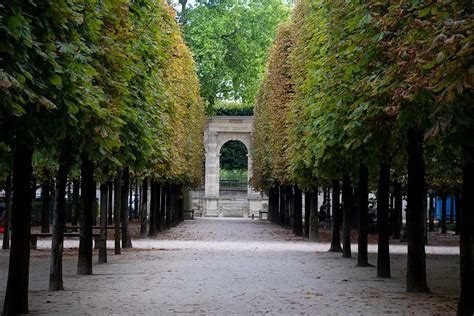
456;157;474;315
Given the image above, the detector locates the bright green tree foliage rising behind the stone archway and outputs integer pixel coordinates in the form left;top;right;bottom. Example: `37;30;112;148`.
184;0;289;107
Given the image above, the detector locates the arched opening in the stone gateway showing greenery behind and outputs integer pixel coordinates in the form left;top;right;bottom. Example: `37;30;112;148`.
219;140;248;191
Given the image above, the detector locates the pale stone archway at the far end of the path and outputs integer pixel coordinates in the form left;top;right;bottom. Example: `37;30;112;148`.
203;116;261;216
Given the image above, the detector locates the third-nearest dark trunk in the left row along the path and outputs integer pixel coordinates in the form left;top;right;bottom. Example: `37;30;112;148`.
77;155;95;275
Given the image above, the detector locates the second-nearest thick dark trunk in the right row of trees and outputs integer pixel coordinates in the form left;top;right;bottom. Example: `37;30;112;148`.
407;129;429;293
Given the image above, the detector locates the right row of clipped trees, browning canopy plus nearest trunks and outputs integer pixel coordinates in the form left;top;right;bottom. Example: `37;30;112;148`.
253;0;474;311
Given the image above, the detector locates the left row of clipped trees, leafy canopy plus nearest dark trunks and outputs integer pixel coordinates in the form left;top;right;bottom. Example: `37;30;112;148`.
0;0;204;314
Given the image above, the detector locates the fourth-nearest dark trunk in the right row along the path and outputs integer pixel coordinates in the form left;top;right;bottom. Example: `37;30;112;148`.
357;163;371;267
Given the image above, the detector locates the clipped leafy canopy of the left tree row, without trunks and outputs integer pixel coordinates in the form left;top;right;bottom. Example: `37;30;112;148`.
0;0;204;186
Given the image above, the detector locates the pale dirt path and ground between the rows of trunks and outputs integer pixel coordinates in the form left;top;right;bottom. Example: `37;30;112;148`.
0;219;459;315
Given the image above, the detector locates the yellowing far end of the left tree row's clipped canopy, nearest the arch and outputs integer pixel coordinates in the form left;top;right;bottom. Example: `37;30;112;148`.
160;7;204;186
